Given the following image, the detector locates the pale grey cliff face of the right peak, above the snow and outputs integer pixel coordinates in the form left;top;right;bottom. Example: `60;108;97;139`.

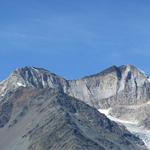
68;65;150;108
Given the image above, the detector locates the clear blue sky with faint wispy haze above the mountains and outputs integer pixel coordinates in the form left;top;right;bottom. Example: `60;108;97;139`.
0;0;150;80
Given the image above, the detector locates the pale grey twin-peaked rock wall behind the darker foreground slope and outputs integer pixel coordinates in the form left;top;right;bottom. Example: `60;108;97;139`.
0;65;150;109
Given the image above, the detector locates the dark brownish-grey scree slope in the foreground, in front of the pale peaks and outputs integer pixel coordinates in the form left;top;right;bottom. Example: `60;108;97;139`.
0;87;146;150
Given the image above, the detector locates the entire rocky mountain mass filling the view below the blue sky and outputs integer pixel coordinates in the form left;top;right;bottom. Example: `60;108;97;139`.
0;65;150;150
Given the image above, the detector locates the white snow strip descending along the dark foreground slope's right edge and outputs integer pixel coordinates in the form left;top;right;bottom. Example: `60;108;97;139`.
98;108;150;149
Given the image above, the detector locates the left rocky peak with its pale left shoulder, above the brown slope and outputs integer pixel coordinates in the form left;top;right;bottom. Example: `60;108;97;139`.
0;66;65;99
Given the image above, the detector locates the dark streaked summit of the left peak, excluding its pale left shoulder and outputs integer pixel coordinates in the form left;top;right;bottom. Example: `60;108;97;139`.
13;66;67;88
